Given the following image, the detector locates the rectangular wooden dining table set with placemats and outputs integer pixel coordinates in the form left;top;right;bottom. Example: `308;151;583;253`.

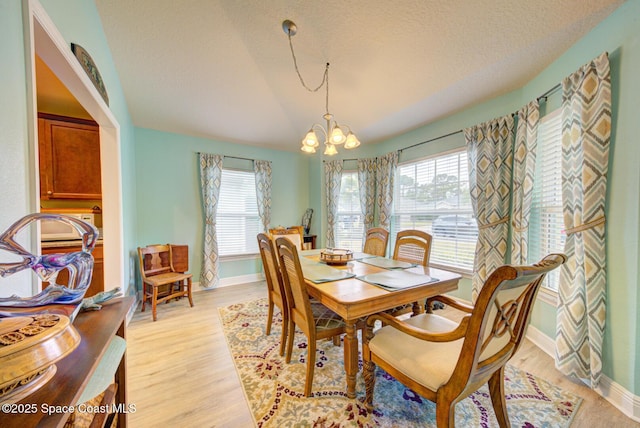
302;251;461;398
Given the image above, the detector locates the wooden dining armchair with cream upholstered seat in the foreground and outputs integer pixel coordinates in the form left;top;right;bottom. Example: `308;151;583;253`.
363;254;566;427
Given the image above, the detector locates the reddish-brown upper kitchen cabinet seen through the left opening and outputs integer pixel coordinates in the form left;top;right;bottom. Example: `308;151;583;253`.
38;113;102;200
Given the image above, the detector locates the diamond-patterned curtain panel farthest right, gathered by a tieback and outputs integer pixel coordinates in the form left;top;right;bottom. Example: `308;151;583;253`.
556;53;611;388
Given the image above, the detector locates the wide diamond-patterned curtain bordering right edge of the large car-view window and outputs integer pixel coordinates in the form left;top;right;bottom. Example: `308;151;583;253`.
464;115;514;302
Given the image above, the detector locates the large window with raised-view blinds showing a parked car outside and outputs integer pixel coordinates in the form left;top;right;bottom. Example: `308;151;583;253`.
391;149;478;271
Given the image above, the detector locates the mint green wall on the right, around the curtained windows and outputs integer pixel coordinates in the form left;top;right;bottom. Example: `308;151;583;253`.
338;1;640;394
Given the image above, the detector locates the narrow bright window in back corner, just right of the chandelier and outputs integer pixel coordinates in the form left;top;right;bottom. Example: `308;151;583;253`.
335;171;364;251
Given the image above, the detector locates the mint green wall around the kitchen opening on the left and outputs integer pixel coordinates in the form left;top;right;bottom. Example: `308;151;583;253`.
0;0;136;294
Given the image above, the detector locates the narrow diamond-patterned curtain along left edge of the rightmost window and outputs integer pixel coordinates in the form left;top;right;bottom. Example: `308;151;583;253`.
511;100;540;265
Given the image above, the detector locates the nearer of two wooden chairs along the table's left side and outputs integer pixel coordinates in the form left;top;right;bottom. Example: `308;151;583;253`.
276;237;345;397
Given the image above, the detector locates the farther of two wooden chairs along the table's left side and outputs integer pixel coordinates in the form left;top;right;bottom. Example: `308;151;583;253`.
258;233;289;355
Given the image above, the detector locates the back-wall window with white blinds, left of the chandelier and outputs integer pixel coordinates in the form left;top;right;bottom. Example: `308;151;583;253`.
216;169;262;257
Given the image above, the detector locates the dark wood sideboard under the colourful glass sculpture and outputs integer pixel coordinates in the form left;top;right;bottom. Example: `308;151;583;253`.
0;296;134;428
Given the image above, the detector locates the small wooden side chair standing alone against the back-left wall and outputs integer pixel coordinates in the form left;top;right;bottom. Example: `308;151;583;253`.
138;244;193;321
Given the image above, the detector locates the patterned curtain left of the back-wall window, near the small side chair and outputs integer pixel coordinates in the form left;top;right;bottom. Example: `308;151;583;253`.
200;153;222;288
